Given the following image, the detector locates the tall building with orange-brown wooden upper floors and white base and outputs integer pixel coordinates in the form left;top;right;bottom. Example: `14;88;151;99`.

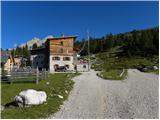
31;36;87;72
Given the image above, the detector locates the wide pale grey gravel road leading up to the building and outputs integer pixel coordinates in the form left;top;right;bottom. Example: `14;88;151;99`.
49;69;159;119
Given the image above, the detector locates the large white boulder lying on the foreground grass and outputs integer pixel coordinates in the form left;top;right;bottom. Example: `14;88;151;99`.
14;89;47;107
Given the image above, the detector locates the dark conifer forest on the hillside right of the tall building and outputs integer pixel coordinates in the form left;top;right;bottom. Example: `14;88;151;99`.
75;27;159;57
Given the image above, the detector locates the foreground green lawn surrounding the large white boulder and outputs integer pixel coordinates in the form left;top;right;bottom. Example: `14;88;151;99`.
1;73;78;119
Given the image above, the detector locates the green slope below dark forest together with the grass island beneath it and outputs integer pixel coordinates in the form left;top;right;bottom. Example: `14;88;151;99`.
91;52;159;80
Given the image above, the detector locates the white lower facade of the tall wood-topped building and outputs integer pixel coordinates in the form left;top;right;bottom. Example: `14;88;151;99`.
49;55;74;72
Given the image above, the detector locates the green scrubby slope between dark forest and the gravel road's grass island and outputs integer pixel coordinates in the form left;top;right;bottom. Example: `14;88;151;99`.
97;53;159;71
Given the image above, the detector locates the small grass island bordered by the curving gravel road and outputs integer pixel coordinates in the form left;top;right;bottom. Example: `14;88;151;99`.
97;69;127;80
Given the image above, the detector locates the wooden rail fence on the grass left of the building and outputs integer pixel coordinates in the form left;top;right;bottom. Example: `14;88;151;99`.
1;69;48;84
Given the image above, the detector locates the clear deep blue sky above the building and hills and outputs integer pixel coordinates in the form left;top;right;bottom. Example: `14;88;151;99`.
1;1;159;49
